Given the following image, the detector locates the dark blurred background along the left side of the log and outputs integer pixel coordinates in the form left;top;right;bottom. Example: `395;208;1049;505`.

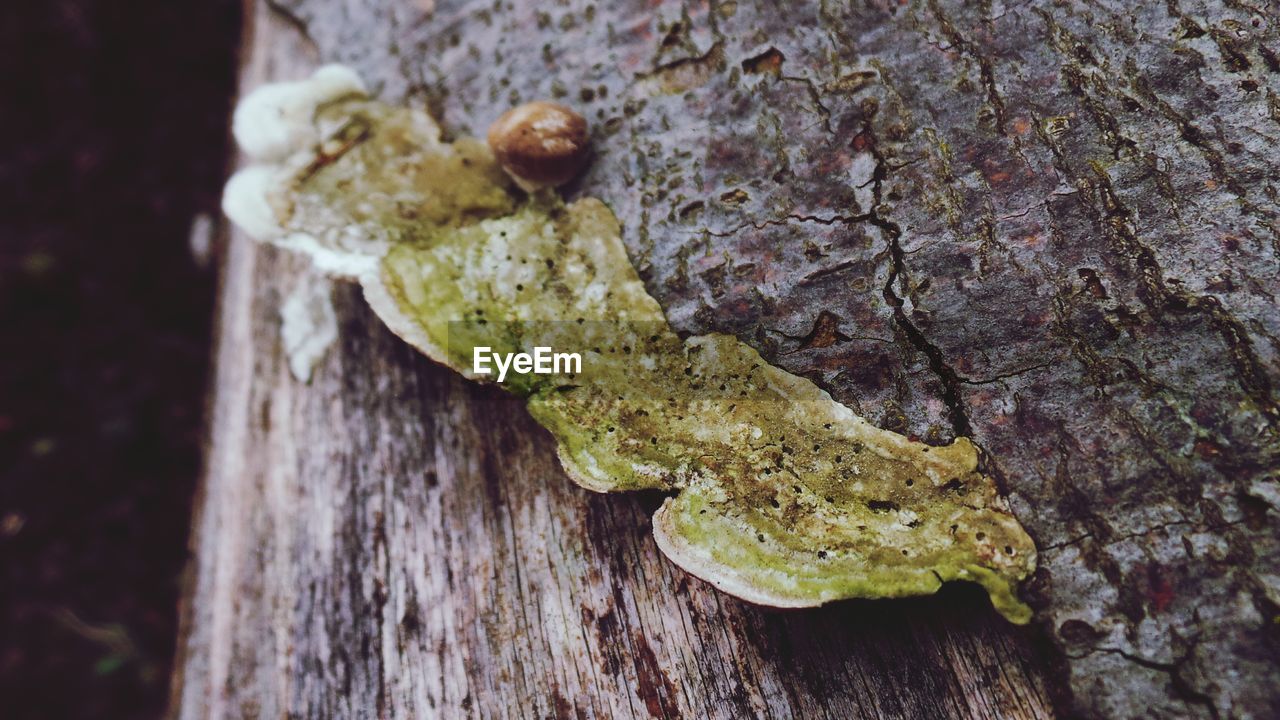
0;0;241;720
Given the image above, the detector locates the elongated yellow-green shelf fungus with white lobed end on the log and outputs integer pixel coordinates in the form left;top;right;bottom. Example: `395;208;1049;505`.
223;67;1036;623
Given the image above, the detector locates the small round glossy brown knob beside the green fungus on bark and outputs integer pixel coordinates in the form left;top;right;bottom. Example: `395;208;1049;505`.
489;101;588;191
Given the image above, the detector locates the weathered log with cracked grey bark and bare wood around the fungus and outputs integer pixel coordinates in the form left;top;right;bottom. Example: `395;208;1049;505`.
180;0;1280;717
